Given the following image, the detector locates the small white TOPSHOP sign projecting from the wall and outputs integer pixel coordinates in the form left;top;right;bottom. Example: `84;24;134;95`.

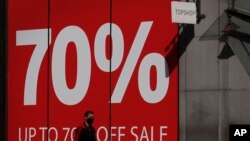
171;1;197;24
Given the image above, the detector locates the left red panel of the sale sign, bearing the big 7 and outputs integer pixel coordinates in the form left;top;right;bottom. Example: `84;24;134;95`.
7;0;49;141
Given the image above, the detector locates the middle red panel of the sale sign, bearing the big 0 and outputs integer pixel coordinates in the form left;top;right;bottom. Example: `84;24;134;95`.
48;0;110;141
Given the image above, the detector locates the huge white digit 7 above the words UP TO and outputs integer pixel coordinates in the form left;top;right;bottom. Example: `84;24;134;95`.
16;29;51;105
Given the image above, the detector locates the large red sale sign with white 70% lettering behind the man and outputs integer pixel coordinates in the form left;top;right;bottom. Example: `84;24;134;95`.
8;0;178;141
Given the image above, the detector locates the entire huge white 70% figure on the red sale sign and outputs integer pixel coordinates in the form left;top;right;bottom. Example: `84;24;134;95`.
16;21;169;105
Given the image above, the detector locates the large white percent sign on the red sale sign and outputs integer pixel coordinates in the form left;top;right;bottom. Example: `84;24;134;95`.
95;21;169;103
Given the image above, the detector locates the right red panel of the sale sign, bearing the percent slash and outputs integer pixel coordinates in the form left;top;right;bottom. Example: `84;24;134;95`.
111;0;178;141
